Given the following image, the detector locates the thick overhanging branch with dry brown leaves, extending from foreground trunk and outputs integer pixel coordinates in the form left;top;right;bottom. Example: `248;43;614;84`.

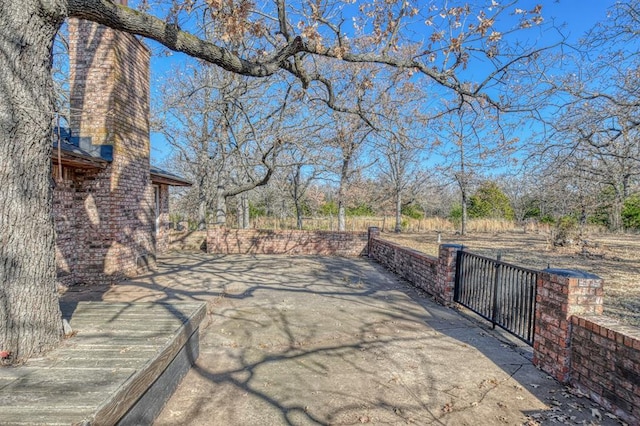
67;0;549;110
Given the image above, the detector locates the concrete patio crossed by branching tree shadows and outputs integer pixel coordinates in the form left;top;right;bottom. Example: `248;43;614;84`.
65;253;620;425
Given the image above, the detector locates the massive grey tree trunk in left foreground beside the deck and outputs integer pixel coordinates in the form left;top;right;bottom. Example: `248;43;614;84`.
0;0;64;363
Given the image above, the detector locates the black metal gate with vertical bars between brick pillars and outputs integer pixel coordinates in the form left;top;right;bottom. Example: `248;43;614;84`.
454;250;538;345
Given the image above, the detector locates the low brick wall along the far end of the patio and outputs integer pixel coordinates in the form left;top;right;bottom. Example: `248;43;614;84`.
207;228;367;256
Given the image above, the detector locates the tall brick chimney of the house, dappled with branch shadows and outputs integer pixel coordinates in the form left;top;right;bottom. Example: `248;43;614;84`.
69;10;155;281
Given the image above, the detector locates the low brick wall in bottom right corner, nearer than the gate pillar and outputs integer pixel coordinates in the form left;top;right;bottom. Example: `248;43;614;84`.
570;316;640;424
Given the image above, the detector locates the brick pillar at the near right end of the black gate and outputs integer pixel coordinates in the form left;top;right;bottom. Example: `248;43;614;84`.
533;269;603;383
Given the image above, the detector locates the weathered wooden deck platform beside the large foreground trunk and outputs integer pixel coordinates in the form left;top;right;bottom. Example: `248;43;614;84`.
0;302;206;425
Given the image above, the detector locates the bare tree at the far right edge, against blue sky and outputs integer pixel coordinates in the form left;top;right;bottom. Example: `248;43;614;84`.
539;0;640;231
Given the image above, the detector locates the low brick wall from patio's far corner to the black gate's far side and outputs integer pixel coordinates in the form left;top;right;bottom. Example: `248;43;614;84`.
369;228;462;305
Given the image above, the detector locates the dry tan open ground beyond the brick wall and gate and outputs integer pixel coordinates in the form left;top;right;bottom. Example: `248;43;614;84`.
382;231;640;326
